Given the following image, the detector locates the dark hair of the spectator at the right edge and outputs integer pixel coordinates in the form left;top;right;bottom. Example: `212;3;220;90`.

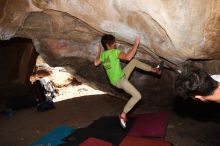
175;69;218;99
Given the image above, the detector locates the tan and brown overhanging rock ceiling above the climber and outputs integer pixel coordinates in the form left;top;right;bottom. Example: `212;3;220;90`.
0;0;220;104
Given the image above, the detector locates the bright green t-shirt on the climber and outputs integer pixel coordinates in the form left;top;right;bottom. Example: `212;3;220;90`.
100;49;124;85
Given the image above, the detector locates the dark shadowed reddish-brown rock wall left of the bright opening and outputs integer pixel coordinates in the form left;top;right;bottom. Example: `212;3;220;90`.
0;38;38;98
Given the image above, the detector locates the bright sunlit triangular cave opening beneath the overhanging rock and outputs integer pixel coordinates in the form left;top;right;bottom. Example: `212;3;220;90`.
30;55;105;102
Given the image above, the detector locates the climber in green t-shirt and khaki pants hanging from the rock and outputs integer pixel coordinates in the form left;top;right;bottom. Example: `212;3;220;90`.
94;34;161;128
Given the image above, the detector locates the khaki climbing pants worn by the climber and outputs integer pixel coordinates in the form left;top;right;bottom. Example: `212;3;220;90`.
116;59;152;114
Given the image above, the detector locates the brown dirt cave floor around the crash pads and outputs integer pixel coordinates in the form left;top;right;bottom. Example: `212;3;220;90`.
0;94;220;146
